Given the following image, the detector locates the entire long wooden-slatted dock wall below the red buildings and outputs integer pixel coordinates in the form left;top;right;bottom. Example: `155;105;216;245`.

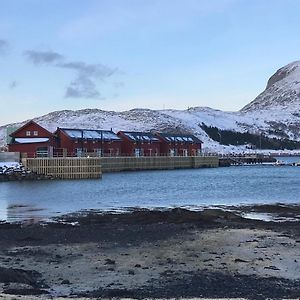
22;156;219;179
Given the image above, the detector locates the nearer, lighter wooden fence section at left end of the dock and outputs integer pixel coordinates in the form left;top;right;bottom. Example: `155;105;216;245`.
22;157;102;179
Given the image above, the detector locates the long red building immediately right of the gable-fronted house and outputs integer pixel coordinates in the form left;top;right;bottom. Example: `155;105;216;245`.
55;127;122;156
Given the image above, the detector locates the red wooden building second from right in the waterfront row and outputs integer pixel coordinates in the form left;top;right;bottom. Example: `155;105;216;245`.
117;131;160;156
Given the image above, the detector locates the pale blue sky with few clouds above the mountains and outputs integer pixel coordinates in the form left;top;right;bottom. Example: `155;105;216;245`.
0;0;300;126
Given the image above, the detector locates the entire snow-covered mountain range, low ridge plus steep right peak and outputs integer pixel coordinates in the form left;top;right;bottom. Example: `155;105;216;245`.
0;61;300;151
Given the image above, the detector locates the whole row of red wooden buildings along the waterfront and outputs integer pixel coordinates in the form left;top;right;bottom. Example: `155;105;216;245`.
8;121;202;157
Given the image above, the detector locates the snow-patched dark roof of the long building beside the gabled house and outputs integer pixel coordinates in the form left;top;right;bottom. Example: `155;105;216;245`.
57;128;121;141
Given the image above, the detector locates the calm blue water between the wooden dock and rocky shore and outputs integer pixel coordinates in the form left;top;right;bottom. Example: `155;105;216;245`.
0;159;300;221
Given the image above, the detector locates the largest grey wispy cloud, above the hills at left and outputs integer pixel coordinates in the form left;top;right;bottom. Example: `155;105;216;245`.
24;50;118;99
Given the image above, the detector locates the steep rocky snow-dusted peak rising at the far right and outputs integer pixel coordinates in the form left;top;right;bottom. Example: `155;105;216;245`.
240;61;300;140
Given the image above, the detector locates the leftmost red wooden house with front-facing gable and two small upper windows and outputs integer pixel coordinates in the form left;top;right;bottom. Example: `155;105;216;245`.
8;120;56;157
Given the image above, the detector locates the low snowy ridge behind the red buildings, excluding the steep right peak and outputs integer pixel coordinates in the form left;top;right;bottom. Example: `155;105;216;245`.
0;107;254;151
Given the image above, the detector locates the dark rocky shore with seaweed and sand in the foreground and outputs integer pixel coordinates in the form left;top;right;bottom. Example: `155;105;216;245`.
0;204;300;299
